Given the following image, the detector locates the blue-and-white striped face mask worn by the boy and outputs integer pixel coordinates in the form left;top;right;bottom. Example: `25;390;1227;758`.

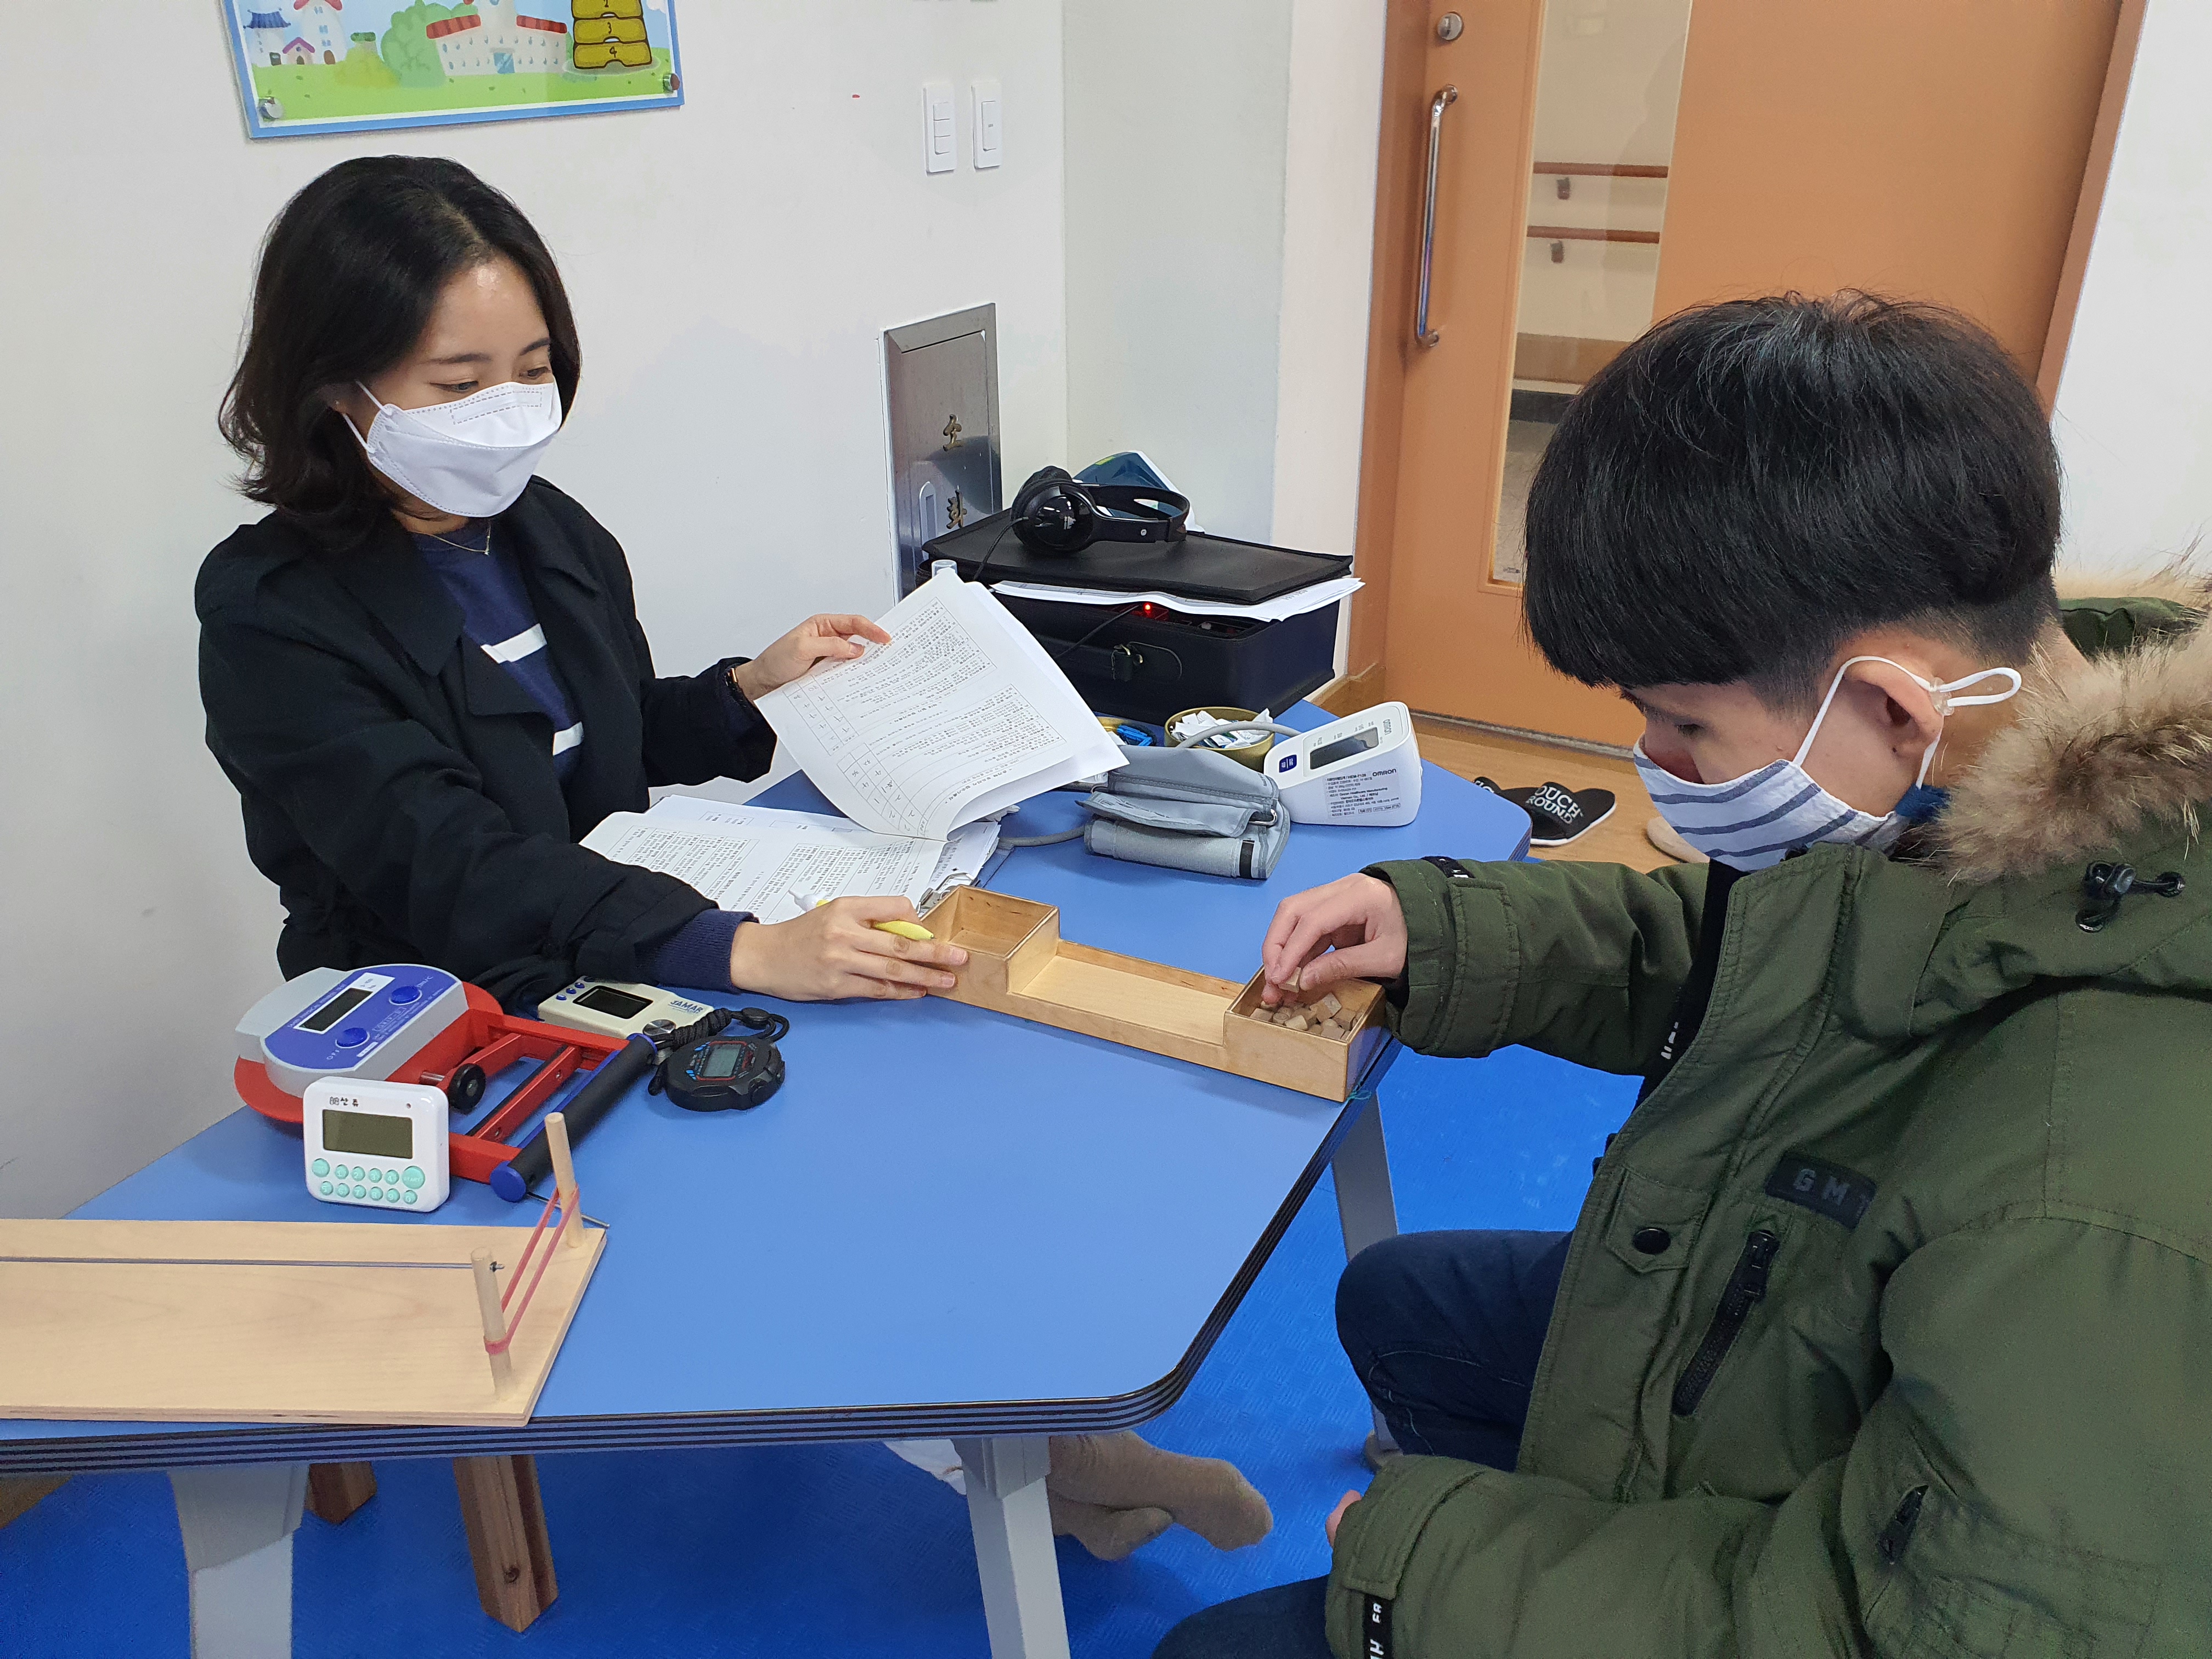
1635;657;2019;870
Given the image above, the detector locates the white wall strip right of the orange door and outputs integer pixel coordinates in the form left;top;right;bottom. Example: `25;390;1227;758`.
2053;0;2212;571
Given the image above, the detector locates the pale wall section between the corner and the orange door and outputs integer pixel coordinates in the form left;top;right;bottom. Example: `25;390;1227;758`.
1057;0;1383;553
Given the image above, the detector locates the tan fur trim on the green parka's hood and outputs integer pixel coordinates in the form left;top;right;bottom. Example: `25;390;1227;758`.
1936;589;2212;883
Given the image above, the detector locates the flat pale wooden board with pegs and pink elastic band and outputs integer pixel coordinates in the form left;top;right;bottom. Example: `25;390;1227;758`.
0;1219;606;1425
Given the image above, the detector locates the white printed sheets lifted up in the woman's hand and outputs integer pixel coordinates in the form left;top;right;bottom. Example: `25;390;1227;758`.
757;573;1126;840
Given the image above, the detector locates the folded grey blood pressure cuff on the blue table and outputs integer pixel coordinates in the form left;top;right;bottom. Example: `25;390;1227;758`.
1084;748;1290;881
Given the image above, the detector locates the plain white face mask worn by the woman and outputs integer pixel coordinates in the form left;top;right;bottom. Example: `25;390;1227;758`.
345;381;560;517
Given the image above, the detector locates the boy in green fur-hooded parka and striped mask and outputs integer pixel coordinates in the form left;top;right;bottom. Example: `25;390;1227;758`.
1159;296;2212;1659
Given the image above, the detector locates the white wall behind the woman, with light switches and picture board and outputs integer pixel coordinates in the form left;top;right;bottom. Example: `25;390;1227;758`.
0;0;1068;1215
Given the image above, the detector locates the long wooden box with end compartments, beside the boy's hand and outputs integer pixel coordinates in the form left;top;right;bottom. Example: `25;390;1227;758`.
924;887;1387;1099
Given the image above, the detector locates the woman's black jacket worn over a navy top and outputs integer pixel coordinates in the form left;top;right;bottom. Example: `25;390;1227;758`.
195;478;776;1007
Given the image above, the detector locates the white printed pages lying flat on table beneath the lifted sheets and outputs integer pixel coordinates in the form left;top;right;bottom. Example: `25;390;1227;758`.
584;801;960;922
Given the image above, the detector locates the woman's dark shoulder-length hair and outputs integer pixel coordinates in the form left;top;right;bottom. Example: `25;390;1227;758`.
219;155;582;542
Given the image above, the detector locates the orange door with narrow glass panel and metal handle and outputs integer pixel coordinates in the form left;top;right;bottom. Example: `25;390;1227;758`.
1352;0;2121;743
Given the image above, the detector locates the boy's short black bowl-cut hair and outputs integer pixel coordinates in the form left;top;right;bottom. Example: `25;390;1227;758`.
1524;294;2059;710
